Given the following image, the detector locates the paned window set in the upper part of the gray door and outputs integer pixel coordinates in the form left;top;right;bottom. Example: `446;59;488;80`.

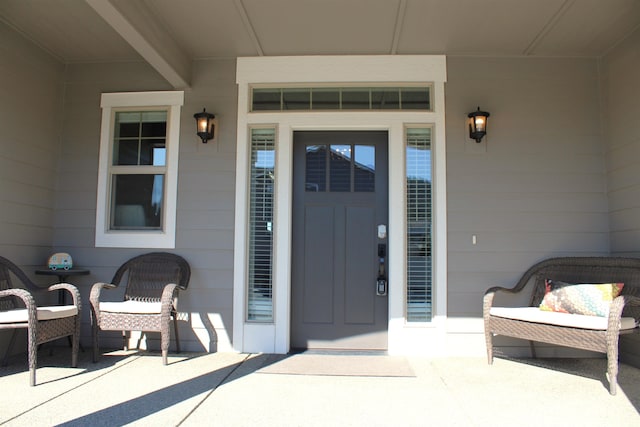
305;144;376;192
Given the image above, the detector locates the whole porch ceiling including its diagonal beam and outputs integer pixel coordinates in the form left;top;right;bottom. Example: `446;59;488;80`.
0;0;640;87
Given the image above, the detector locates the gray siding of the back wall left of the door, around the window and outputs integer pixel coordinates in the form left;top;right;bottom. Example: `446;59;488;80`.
53;60;237;351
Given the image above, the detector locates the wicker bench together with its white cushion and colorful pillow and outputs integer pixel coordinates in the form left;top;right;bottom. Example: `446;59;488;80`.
483;257;640;394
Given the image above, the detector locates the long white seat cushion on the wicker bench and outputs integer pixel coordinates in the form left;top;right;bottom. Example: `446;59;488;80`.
489;307;637;331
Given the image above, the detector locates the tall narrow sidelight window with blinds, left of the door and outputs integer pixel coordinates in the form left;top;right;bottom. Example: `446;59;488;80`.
247;129;275;322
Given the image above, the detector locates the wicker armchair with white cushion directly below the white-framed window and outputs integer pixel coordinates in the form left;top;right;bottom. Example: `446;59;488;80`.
89;252;191;365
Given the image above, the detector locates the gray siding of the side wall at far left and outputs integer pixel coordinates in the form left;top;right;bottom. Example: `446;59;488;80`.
0;22;64;358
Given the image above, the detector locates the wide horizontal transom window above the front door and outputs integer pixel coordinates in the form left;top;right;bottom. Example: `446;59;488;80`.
251;85;432;112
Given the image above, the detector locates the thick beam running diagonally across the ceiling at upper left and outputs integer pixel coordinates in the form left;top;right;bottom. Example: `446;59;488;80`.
86;0;191;89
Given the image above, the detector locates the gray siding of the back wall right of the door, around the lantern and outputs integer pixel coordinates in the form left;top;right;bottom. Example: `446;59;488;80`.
446;57;610;328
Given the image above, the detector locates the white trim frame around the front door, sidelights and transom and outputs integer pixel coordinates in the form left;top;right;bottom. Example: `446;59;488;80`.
233;56;447;354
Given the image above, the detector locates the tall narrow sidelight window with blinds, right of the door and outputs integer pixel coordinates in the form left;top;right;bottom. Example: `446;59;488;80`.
406;127;432;322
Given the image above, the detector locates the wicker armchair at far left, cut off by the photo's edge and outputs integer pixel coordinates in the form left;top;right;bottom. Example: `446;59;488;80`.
0;257;80;386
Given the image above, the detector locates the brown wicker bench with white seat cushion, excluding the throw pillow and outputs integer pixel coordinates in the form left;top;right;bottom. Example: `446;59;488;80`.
483;257;640;395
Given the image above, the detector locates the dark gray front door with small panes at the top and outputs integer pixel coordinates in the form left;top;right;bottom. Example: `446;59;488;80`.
291;131;388;350
